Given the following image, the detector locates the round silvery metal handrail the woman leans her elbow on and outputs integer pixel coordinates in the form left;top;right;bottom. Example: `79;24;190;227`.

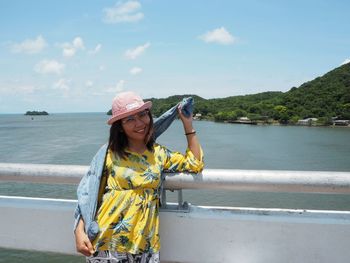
0;163;350;194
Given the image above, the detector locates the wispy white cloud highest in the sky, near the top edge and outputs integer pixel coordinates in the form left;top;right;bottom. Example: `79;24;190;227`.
103;1;144;24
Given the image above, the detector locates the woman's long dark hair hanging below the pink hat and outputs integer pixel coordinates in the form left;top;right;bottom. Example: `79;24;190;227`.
109;111;154;159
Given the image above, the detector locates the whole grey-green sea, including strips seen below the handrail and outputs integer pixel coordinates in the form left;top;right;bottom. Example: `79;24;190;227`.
0;113;350;262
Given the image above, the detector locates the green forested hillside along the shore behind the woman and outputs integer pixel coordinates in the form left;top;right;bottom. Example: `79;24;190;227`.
109;63;350;125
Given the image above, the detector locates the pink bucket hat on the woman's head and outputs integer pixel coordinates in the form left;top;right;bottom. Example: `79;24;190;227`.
107;91;152;125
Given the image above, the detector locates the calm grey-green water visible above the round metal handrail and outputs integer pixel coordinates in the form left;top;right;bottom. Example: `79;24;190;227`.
0;113;350;171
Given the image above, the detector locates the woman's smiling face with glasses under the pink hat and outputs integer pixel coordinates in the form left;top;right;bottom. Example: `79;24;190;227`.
121;110;151;145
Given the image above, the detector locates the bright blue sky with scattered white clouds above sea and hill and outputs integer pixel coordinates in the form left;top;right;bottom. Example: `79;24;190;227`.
0;0;350;113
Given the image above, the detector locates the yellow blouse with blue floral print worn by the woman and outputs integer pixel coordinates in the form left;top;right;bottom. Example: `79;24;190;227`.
93;144;204;254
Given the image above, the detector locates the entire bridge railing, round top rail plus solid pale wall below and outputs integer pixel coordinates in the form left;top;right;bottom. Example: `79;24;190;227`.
0;164;350;263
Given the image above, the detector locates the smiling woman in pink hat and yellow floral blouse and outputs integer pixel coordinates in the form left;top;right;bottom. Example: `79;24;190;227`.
75;92;203;262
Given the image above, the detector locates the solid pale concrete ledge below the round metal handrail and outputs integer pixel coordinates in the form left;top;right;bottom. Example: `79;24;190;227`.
0;196;350;263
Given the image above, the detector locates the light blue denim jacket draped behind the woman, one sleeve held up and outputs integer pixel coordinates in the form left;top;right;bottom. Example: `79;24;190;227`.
74;97;193;241
